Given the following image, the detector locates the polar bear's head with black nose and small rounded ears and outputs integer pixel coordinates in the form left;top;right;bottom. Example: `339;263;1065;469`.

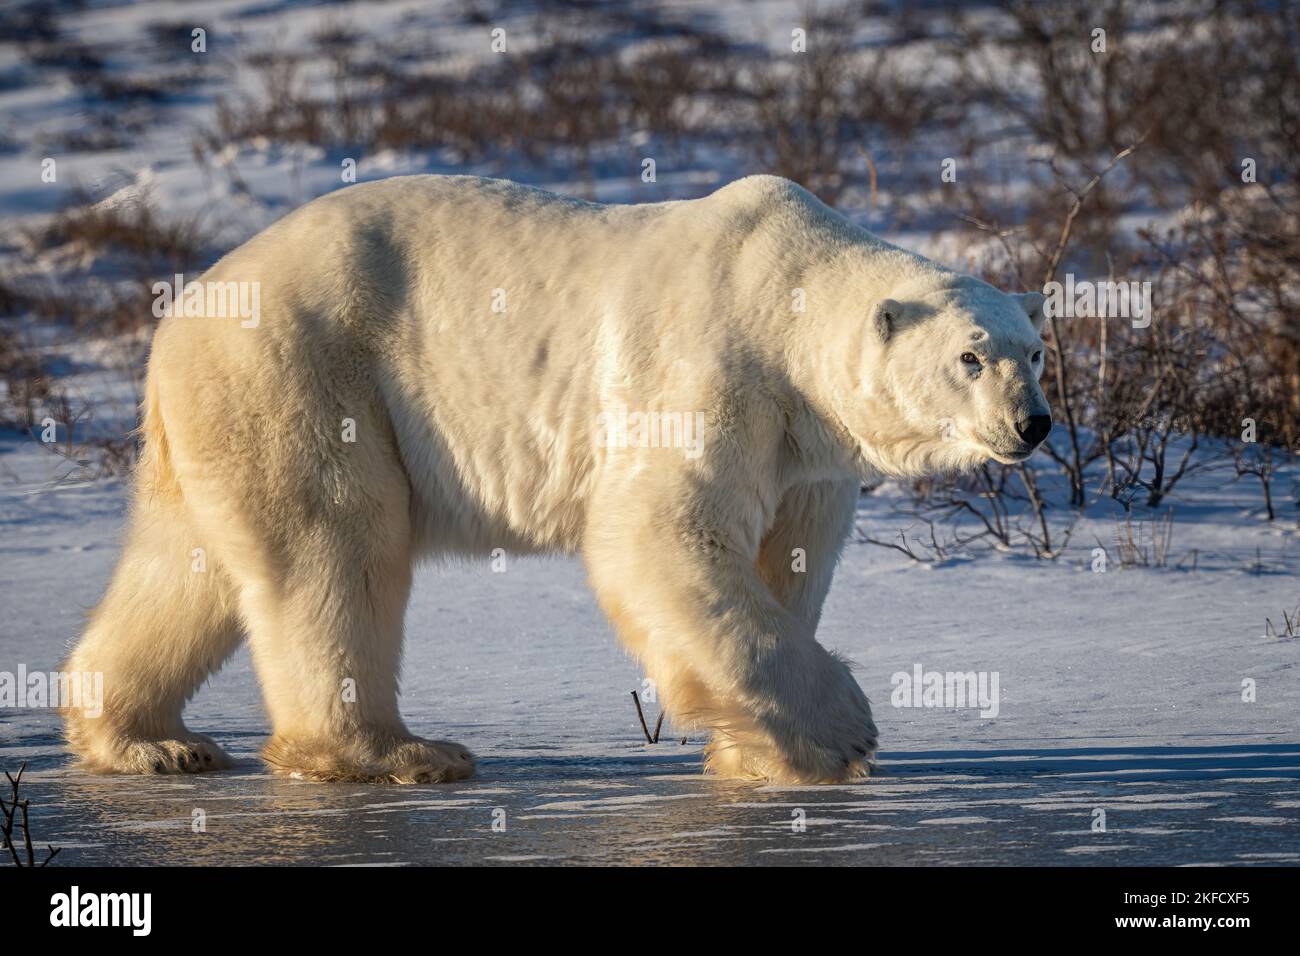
850;274;1052;476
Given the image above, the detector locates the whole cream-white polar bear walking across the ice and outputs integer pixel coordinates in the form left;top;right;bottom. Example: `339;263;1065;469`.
66;176;1050;783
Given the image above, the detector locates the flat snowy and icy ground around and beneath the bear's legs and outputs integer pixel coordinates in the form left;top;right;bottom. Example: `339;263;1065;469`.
0;445;1300;865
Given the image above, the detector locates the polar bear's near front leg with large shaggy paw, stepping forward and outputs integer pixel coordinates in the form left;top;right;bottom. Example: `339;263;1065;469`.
584;484;876;783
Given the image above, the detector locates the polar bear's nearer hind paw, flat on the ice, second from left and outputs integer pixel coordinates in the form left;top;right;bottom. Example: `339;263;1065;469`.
261;736;475;783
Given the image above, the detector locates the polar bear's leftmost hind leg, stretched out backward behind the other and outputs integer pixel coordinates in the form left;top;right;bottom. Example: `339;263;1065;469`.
62;489;242;774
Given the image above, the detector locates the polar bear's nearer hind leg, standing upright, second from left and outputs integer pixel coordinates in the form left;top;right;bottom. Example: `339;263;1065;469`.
227;455;475;783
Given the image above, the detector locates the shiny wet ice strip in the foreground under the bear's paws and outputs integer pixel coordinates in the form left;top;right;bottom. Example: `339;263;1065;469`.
15;723;1300;865
